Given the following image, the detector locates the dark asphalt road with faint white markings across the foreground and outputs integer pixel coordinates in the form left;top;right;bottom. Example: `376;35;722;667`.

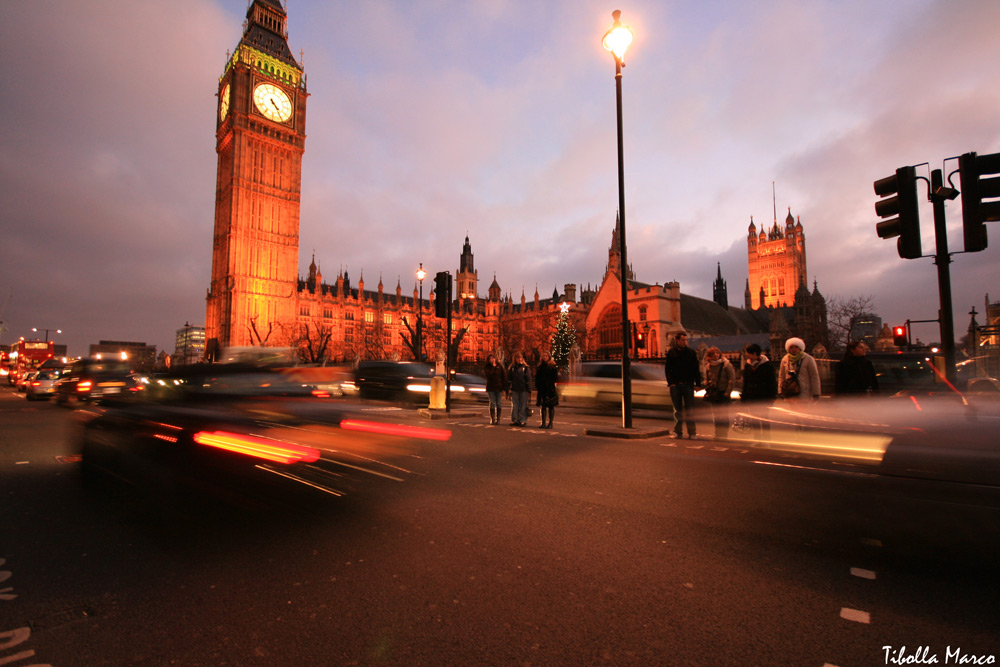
0;387;1000;667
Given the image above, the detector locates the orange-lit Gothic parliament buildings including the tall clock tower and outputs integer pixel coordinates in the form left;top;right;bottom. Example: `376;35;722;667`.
205;0;826;363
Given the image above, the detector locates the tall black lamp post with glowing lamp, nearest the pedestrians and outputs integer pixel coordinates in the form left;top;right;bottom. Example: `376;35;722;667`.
604;9;632;428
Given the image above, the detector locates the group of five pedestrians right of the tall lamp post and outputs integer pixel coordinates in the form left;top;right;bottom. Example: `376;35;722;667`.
664;332;878;439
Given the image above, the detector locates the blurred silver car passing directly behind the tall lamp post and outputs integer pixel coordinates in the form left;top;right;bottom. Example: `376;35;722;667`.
556;361;673;410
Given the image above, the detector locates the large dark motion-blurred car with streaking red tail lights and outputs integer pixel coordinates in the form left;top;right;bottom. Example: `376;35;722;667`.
79;364;450;511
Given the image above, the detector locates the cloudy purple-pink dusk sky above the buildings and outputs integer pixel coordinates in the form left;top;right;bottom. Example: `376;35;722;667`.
0;0;1000;356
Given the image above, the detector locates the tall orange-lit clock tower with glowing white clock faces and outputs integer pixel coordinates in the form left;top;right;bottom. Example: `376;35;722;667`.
205;0;307;354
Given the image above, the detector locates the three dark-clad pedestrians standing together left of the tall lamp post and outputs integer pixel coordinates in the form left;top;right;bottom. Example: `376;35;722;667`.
483;352;559;428
